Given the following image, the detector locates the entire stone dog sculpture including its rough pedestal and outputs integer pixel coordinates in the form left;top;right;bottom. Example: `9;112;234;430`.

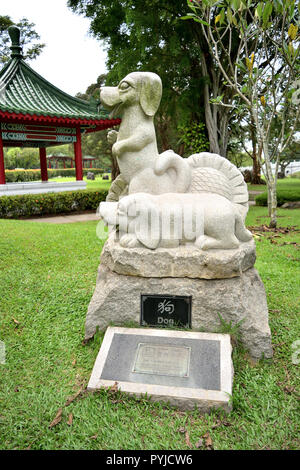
85;72;272;362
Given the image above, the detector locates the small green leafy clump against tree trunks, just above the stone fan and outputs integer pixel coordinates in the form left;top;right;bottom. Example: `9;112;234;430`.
179;122;209;153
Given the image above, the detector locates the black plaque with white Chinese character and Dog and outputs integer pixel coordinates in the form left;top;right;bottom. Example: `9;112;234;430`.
141;294;192;328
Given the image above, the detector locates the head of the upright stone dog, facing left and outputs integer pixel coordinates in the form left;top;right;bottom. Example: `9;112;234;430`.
100;72;162;117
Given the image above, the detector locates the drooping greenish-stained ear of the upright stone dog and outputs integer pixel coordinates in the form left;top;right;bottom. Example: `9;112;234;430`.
140;72;162;116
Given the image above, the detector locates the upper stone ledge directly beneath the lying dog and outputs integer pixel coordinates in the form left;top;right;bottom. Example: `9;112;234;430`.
101;233;256;279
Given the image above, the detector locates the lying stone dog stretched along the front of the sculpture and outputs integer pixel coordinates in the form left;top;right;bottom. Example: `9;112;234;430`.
100;193;252;250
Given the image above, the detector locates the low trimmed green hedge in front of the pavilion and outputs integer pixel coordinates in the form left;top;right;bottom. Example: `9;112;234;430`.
0;190;107;219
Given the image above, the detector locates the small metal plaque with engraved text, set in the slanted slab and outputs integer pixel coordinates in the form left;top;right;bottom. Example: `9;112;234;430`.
132;343;191;377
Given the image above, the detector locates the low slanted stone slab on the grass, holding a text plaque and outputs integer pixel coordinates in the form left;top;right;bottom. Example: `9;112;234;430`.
88;327;233;412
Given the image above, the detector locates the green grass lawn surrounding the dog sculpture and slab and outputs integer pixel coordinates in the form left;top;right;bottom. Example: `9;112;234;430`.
0;207;300;450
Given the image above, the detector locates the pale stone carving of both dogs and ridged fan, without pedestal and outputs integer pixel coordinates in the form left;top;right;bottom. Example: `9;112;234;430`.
99;72;252;250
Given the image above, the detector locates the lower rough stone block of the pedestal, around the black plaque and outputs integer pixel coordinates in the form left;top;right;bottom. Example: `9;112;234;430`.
85;263;272;358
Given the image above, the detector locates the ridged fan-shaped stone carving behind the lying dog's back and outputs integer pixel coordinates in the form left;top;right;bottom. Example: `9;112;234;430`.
187;152;249;221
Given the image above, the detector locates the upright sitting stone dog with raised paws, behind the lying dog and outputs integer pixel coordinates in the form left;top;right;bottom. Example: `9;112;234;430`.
100;72;191;194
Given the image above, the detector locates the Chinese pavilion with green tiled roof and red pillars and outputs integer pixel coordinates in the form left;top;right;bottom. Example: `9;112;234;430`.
0;26;120;195
